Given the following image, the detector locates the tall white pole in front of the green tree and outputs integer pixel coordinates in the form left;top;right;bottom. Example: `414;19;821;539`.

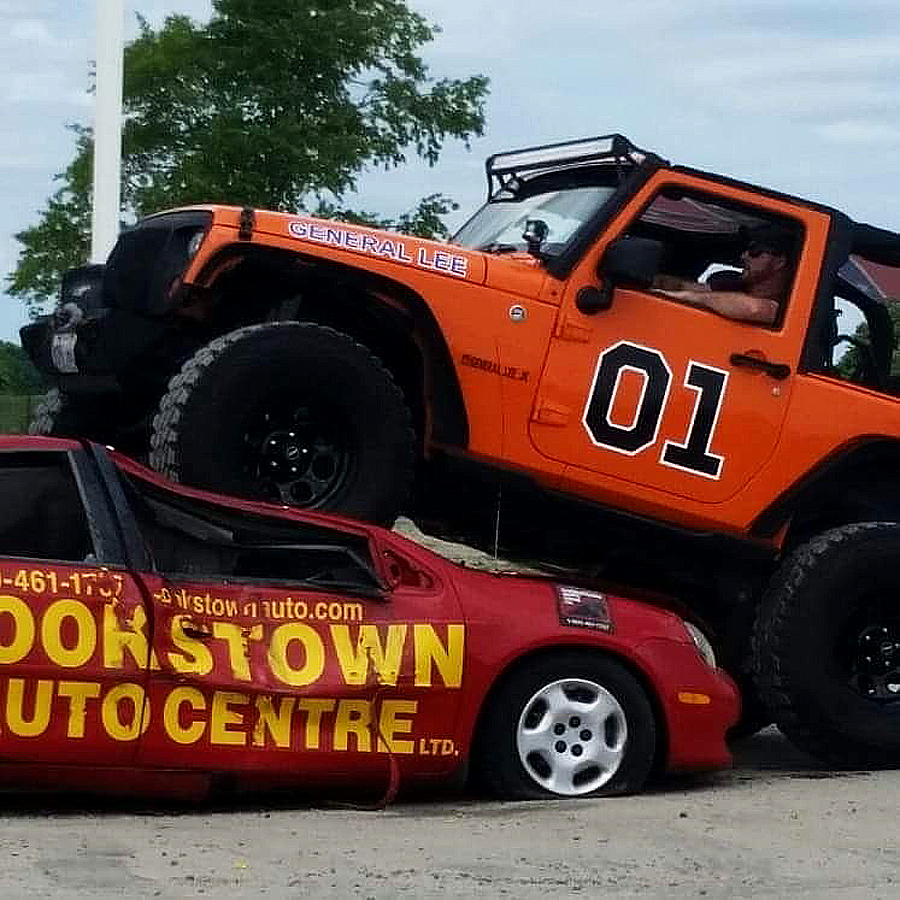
91;0;125;263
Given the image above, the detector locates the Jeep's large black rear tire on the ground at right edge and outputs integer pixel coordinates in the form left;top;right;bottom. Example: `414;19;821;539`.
753;522;900;768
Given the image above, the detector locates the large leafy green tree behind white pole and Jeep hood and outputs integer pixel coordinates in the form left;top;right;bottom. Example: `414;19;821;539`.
8;0;487;309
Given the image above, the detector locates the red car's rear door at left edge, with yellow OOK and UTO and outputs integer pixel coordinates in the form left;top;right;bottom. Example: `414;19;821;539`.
0;441;149;767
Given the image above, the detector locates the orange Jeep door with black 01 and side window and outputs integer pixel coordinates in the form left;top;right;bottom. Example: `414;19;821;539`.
530;172;828;503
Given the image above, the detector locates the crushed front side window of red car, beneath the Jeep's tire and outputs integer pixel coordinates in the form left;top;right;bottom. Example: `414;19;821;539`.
122;473;383;593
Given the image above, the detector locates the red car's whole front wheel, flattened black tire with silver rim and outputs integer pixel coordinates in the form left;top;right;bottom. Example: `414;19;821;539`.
473;651;656;800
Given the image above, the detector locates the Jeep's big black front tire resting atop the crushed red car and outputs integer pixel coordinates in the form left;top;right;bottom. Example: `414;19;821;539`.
150;322;415;523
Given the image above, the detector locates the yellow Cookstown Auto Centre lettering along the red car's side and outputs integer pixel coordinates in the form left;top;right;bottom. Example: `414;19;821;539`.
0;596;465;756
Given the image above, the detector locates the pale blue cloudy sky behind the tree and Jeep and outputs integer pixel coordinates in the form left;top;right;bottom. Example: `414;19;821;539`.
0;0;900;342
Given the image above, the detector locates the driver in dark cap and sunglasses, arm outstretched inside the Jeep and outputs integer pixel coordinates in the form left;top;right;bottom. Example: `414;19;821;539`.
653;225;793;325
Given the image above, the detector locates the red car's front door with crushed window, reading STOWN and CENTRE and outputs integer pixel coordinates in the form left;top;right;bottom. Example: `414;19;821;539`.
113;468;464;779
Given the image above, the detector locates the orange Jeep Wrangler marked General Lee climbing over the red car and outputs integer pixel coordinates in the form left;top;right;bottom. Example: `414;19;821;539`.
22;135;900;766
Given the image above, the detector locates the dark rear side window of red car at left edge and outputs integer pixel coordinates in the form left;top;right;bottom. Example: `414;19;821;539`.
0;452;96;562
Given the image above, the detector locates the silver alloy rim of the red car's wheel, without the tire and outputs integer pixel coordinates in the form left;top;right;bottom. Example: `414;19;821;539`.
516;678;628;796
